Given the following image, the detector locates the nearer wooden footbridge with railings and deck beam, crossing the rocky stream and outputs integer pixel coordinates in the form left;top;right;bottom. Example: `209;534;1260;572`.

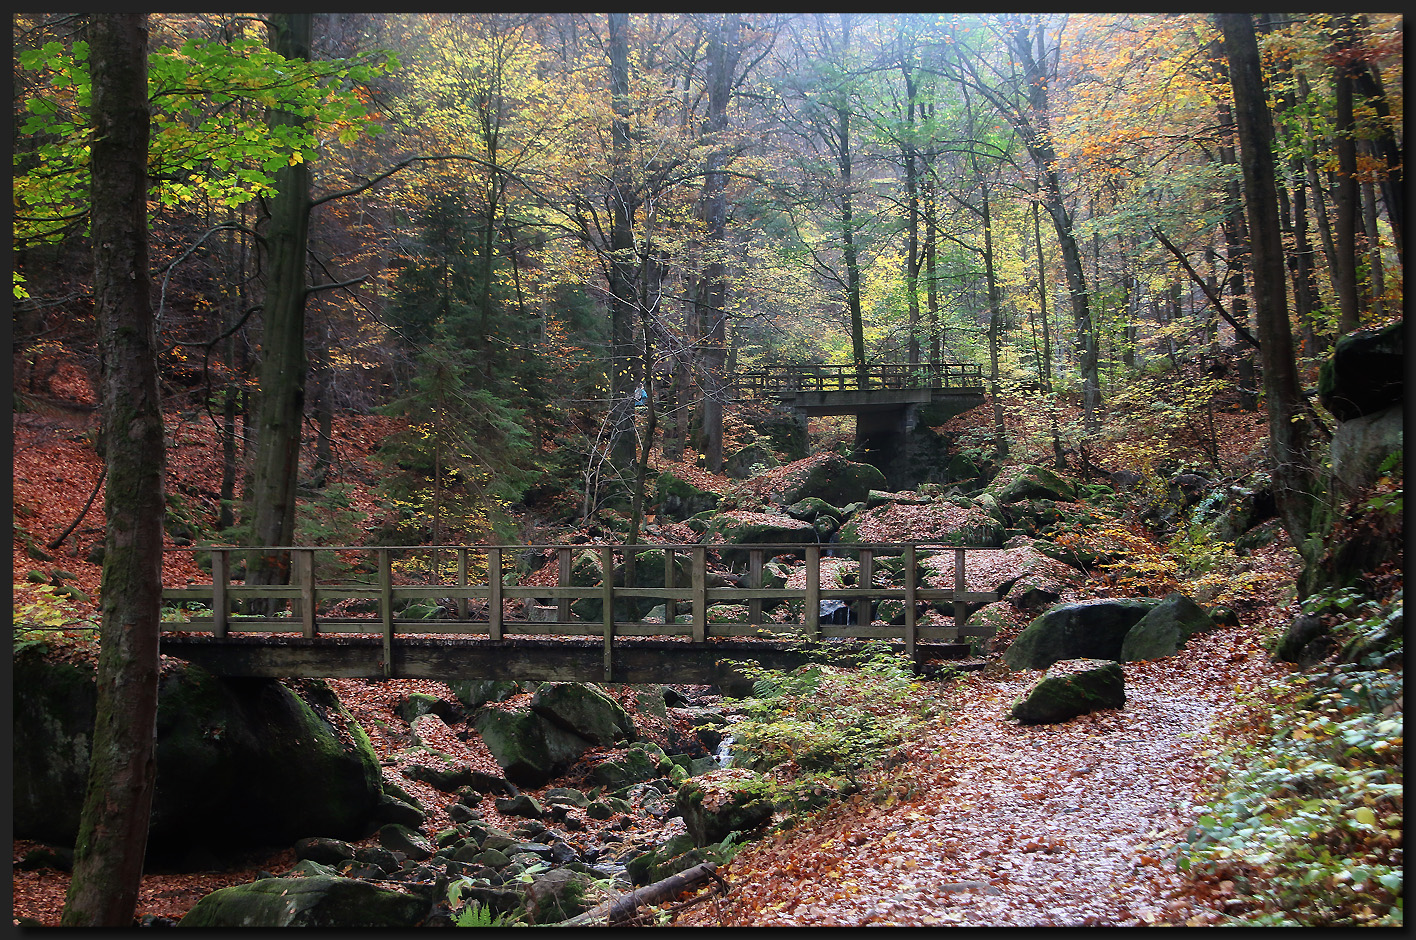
161;542;998;685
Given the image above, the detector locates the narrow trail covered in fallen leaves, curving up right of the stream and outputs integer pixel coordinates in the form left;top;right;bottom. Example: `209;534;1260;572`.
674;629;1283;926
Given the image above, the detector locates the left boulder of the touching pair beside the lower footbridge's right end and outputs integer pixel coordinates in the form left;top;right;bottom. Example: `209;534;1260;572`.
1003;597;1160;670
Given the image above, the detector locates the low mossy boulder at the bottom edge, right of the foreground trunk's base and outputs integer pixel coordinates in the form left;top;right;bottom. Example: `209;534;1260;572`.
180;875;430;927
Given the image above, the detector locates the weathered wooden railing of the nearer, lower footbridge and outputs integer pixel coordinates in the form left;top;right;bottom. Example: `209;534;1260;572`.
163;542;998;676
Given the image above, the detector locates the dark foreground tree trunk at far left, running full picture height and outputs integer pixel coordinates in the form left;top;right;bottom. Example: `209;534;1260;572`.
59;13;166;927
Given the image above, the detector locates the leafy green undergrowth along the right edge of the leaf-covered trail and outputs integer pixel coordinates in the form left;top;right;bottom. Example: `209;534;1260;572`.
1178;599;1403;927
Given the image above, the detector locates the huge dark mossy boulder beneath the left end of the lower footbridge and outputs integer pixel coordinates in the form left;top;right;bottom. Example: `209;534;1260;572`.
13;651;382;858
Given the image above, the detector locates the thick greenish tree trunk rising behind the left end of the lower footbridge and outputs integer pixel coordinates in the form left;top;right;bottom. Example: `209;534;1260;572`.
246;13;313;594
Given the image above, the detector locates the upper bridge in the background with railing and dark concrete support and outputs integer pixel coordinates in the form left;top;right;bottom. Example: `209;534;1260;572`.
735;362;984;490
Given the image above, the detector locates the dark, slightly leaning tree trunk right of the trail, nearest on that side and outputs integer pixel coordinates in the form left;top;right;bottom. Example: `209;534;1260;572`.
1215;13;1317;556
